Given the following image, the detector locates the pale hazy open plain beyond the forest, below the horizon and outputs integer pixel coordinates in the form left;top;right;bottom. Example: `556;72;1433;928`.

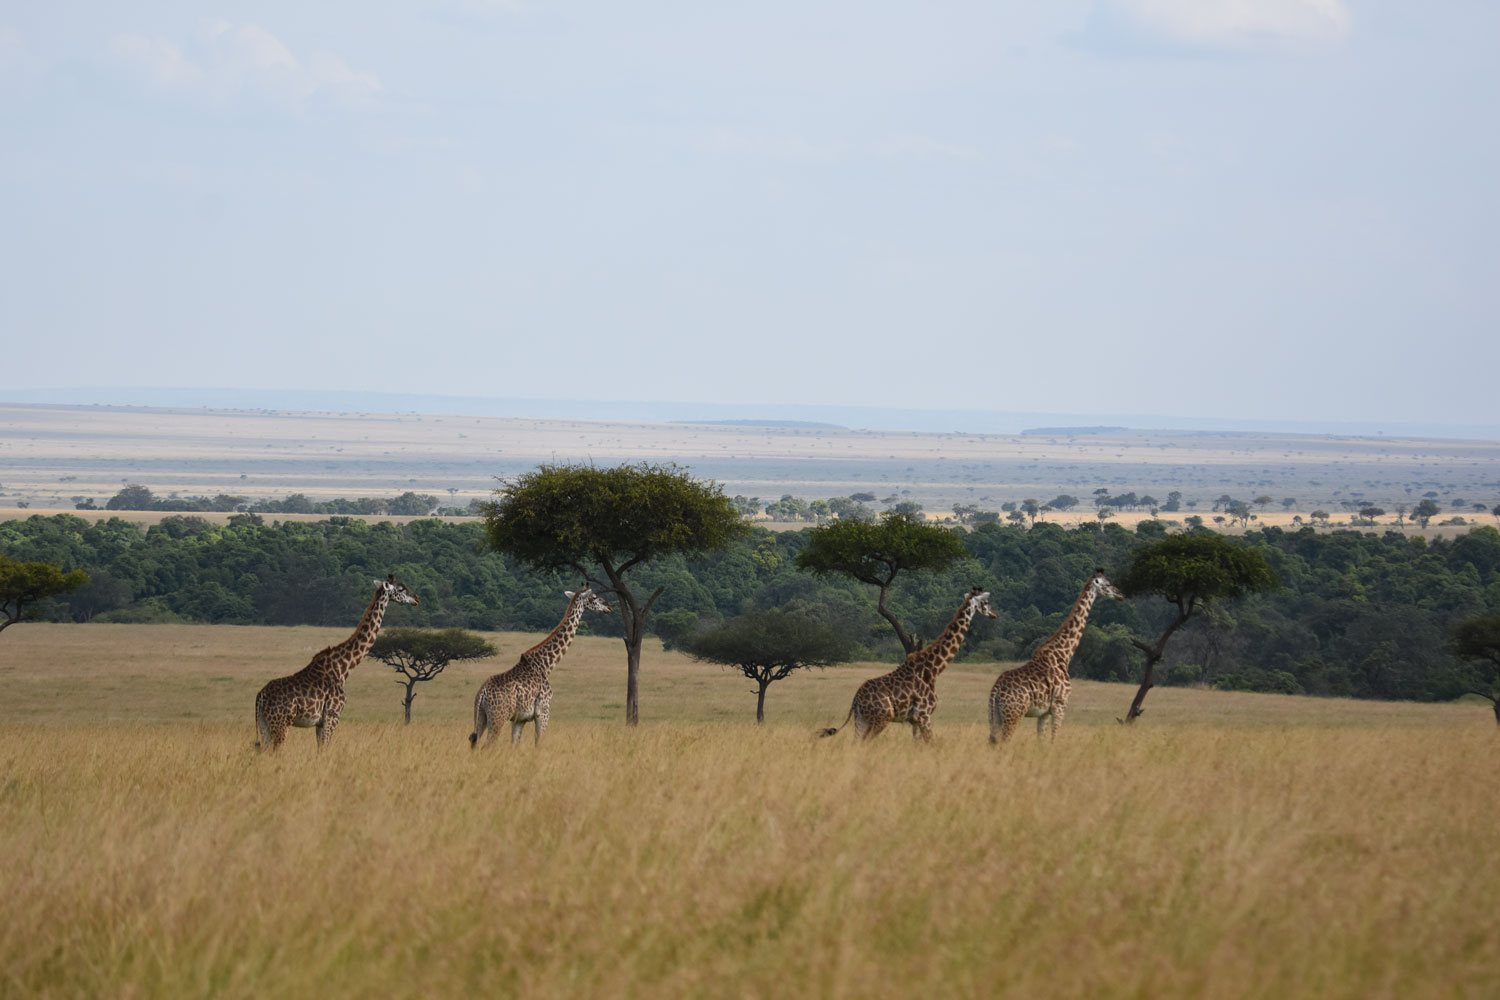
0;403;1500;523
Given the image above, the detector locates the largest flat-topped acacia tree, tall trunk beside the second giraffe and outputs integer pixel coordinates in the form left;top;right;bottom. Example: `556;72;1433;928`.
480;463;749;726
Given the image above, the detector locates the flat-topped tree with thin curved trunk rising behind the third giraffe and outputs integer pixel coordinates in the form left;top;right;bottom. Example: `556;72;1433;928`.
797;511;968;654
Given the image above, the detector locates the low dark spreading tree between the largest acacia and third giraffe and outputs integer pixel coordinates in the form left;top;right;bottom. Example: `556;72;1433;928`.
680;609;851;724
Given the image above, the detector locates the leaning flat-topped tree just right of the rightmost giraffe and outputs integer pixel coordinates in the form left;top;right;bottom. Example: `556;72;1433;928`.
1115;534;1281;723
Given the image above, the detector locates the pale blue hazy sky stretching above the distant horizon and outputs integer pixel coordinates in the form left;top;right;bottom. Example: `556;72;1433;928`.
0;0;1500;424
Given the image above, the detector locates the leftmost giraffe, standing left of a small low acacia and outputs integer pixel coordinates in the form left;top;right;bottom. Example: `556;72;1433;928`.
255;574;422;750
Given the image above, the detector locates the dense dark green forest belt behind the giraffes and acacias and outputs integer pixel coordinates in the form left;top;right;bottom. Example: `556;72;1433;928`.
0;514;1500;700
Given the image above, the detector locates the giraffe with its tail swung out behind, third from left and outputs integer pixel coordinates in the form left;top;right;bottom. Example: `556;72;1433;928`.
818;588;996;741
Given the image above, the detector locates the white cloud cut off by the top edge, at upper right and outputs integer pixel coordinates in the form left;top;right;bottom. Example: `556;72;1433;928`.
1107;0;1353;48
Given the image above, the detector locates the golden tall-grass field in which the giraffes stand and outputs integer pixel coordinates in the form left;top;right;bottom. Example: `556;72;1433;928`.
0;622;1500;999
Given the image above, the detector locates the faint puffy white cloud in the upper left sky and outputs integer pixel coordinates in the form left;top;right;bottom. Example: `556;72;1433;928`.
110;21;381;106
